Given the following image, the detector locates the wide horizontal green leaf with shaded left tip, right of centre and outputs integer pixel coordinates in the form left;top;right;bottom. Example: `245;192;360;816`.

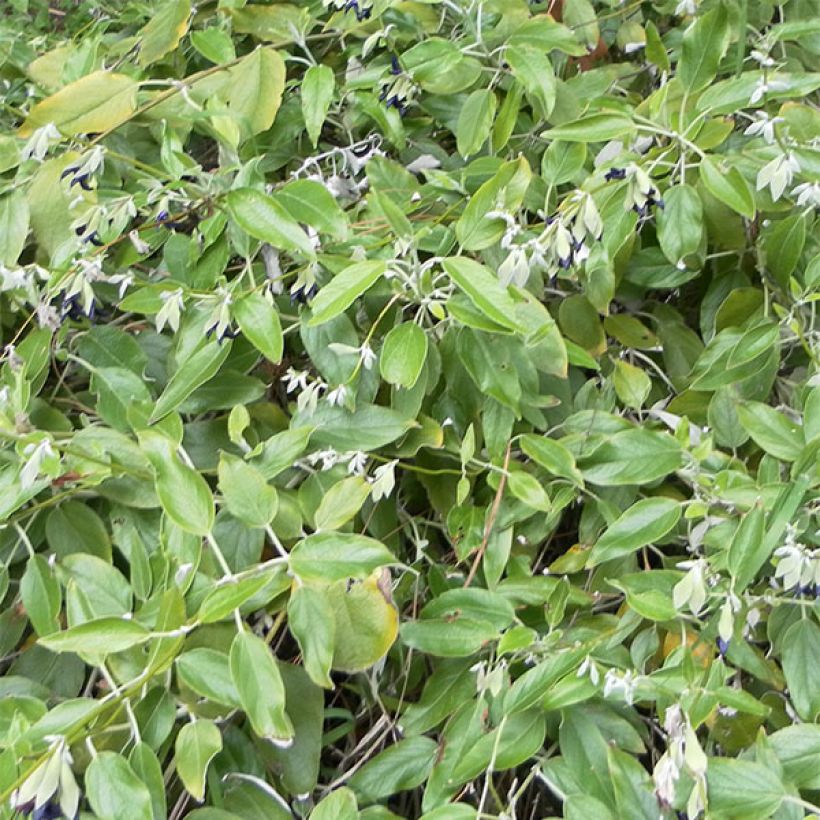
578;428;683;487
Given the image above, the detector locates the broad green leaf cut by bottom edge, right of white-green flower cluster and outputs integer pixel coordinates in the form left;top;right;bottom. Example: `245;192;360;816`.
706;757;784;817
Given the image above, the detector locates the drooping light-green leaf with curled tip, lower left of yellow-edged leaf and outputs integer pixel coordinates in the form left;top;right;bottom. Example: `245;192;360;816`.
230;629;293;745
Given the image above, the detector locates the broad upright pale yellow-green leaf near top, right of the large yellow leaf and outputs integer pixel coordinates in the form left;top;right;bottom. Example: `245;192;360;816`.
228;48;285;138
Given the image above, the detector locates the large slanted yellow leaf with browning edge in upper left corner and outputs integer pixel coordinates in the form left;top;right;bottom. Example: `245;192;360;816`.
20;71;138;137
